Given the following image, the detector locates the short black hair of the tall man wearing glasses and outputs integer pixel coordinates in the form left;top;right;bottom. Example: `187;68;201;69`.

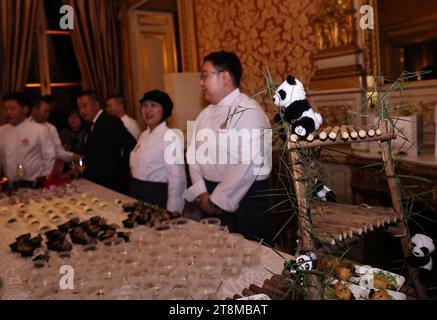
203;50;243;88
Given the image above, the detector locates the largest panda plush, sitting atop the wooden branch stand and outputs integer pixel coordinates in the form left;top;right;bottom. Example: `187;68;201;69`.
273;75;323;139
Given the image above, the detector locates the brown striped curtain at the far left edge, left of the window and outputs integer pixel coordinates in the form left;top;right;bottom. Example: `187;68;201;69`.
0;0;39;96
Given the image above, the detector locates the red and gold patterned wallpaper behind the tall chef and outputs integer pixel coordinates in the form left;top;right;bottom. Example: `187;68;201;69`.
194;0;316;115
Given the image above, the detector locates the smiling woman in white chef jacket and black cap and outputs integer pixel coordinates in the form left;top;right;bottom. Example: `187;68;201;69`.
129;90;186;212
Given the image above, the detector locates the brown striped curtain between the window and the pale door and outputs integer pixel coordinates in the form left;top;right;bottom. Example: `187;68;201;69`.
64;0;122;99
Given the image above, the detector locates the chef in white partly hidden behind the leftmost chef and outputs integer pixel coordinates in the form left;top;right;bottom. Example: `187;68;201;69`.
29;99;80;162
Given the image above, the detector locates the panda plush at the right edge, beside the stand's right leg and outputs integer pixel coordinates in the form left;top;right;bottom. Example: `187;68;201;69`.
407;233;435;282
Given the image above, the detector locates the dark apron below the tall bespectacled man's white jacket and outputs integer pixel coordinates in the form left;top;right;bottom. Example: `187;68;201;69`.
205;179;273;244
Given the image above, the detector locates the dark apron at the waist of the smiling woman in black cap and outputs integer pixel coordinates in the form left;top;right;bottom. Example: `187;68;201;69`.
129;177;168;208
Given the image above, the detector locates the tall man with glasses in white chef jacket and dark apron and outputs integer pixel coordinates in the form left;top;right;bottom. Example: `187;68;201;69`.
185;51;272;242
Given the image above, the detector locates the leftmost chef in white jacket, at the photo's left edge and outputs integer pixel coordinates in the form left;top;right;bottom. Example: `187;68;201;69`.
0;92;55;181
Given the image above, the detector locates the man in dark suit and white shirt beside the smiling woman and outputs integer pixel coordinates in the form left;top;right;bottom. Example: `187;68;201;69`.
77;90;136;193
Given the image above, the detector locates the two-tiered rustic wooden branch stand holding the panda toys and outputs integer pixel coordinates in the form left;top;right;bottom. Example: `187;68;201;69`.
286;120;426;299
